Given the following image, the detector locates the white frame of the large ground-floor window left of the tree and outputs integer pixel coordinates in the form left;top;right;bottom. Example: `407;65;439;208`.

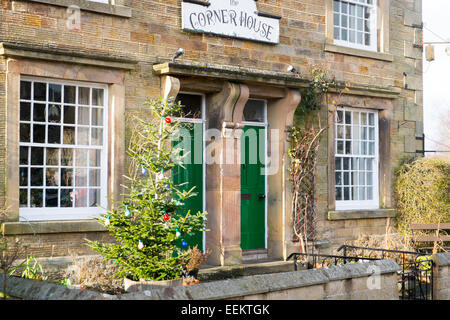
18;77;109;221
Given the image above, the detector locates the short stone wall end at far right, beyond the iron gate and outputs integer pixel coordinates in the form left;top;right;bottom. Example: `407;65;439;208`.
432;252;450;300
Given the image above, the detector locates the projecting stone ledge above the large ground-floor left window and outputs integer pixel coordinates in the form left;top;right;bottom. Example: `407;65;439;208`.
0;42;137;70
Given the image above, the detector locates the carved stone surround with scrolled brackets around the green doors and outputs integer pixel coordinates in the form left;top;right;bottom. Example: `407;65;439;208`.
161;75;300;266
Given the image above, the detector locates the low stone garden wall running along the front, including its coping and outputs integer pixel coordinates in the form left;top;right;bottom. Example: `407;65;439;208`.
0;260;400;300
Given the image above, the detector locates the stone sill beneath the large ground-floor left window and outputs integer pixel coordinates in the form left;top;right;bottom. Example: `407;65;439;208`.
1;220;107;236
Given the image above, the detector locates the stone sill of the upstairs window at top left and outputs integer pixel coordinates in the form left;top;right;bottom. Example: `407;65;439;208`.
28;0;131;18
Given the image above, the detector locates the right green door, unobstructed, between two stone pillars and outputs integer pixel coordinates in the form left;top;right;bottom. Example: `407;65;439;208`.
241;126;266;250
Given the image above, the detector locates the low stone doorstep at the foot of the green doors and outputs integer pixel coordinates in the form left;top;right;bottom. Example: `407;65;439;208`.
198;260;294;281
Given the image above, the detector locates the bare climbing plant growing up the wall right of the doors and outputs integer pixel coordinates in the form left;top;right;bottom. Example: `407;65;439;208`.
289;66;349;252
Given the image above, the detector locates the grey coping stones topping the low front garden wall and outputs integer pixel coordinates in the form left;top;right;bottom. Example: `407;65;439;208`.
0;260;401;300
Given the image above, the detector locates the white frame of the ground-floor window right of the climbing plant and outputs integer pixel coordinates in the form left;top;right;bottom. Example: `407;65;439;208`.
333;107;380;210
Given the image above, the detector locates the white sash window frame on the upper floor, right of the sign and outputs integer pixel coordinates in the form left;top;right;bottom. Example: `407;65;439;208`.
332;0;379;52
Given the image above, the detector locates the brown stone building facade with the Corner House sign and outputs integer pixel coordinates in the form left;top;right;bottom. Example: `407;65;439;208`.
0;0;423;265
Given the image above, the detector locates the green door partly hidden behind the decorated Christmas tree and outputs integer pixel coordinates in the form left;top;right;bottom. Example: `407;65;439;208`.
172;123;204;251
